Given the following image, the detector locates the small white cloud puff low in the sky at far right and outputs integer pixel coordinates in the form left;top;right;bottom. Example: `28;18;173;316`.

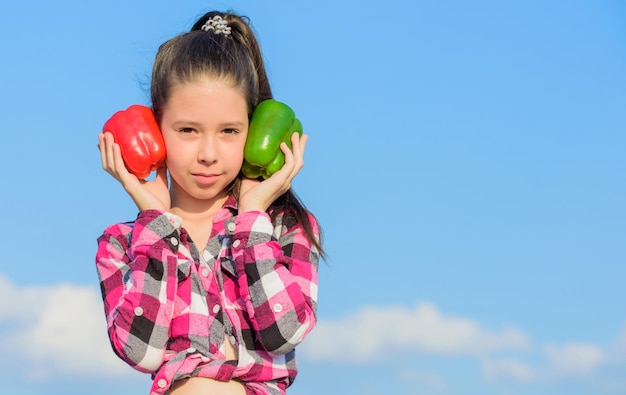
544;343;605;375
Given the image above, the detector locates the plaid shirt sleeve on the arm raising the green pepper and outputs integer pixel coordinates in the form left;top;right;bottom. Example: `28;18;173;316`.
226;212;319;354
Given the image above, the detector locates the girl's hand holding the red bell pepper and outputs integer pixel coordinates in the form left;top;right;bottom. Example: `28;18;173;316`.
98;132;171;211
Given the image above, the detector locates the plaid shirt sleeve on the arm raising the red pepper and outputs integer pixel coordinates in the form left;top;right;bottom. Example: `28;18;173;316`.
96;210;182;372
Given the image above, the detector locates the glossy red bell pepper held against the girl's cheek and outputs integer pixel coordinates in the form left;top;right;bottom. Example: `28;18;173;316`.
102;104;165;179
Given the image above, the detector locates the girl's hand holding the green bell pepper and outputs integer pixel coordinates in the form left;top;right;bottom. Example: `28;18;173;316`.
239;133;308;213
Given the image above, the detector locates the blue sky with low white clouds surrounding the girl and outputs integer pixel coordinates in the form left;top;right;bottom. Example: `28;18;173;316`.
0;0;626;395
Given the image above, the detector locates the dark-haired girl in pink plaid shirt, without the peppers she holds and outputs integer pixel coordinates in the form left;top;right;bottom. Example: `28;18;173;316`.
96;12;322;395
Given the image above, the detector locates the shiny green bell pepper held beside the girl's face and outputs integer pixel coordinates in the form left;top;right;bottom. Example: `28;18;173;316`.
241;99;302;178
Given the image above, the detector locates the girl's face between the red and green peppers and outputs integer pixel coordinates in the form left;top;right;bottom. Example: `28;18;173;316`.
161;79;248;203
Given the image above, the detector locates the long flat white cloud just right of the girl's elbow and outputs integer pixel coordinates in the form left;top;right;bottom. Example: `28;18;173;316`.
301;302;529;362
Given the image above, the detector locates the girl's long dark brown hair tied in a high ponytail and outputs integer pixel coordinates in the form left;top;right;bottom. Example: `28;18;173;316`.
150;11;324;258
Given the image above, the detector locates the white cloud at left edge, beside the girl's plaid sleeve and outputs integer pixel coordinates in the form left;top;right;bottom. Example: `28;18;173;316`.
0;274;133;380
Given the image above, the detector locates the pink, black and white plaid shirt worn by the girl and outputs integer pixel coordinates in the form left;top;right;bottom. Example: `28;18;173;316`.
96;196;319;395
